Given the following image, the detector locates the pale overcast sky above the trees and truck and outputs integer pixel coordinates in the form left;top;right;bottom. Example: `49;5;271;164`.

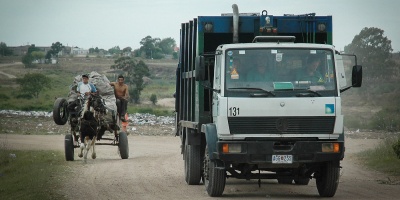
0;0;400;52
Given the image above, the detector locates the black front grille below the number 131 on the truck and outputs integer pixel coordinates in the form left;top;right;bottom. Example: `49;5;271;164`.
228;116;335;134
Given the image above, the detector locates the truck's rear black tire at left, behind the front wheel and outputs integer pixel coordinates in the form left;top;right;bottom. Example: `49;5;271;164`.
184;145;201;185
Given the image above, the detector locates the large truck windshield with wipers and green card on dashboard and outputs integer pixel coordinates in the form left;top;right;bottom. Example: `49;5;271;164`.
225;48;337;97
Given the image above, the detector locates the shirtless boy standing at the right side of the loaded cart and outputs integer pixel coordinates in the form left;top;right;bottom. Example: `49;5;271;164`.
110;75;129;122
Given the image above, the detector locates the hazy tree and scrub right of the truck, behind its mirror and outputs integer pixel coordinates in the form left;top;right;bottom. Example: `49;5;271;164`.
342;27;400;132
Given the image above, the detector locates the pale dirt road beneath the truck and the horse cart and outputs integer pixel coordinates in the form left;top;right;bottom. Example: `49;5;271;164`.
0;134;400;199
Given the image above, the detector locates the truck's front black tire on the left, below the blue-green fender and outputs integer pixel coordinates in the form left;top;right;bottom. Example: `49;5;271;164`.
203;147;226;197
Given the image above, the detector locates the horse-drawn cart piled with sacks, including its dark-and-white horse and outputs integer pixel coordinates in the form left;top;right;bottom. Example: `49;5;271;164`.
53;72;129;161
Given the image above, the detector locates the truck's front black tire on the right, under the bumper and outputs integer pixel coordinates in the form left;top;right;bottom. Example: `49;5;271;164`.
316;162;340;197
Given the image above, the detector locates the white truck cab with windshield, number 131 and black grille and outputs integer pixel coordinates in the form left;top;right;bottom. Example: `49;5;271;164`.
212;42;346;140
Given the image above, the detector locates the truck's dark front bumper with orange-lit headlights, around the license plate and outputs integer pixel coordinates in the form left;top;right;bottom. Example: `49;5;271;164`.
212;141;344;164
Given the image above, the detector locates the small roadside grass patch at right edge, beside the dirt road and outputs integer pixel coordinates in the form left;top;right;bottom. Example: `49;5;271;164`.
359;137;400;176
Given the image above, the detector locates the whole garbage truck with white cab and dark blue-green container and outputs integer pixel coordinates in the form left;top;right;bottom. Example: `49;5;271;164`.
175;4;362;197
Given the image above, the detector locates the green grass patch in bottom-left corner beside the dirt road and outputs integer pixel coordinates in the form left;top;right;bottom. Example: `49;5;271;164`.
0;146;67;200
